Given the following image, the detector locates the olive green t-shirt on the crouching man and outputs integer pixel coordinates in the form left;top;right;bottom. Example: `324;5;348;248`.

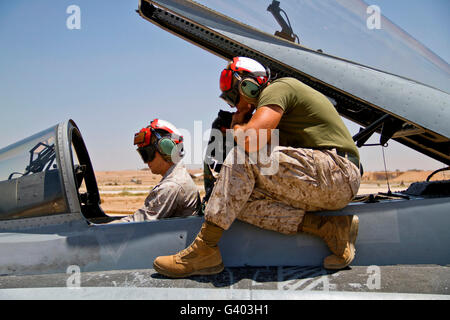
257;78;359;158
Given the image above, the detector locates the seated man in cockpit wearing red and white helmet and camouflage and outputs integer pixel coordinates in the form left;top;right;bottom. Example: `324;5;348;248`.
114;119;201;223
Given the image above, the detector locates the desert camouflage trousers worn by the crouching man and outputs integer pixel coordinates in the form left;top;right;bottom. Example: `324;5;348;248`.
205;147;361;234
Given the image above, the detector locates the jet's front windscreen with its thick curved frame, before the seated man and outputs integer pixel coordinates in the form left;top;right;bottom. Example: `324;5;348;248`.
0;120;114;228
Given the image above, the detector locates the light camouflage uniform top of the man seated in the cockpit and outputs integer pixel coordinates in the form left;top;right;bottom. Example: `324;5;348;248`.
117;162;201;222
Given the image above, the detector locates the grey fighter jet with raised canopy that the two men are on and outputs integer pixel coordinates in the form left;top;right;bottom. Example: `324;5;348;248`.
0;0;450;298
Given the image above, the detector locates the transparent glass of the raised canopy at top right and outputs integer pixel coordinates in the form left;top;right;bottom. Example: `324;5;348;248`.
195;0;450;92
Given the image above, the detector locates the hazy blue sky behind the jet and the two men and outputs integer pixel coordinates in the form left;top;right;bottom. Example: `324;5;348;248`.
0;0;450;171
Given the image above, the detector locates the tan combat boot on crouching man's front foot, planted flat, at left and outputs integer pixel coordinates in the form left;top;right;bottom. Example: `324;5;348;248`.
153;221;224;278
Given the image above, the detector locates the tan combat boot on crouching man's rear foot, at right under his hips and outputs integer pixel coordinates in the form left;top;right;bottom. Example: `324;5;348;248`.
299;213;359;270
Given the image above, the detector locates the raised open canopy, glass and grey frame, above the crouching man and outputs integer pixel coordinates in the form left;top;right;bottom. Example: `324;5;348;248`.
139;0;450;164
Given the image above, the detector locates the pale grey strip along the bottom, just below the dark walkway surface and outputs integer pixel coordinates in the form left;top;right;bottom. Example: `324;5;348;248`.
0;287;450;300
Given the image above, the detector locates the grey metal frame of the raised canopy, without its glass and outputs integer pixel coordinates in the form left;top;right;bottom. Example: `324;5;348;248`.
139;0;450;165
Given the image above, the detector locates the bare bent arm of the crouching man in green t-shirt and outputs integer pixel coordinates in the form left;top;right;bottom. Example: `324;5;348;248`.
232;105;283;152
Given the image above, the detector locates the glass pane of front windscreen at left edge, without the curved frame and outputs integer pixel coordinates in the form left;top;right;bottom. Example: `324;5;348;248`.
0;126;67;220
